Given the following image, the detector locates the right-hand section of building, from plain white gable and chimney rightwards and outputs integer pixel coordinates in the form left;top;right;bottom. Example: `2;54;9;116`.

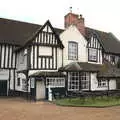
59;13;120;93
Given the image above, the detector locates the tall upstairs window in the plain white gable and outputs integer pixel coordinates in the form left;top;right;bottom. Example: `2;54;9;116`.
68;41;78;60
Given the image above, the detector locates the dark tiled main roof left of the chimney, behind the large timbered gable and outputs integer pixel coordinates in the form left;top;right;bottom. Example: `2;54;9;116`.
0;18;63;46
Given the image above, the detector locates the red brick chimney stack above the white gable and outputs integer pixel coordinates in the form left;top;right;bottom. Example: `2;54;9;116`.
64;11;85;36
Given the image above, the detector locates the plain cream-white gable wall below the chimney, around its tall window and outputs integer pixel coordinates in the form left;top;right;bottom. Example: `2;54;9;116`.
60;25;88;65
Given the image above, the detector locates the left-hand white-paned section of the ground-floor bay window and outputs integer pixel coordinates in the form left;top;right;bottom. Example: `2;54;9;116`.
68;72;80;91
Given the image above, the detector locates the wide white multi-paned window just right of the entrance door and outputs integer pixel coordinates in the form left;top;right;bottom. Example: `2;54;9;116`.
46;77;65;88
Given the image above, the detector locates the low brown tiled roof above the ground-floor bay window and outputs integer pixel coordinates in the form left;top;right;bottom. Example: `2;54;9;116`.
59;62;120;78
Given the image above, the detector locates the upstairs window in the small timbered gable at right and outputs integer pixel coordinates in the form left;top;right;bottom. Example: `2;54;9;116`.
88;48;97;62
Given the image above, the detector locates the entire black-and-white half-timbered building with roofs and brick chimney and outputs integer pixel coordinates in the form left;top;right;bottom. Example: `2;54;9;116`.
0;13;120;100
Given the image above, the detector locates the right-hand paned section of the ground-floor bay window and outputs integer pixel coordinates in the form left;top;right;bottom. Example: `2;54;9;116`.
80;72;90;90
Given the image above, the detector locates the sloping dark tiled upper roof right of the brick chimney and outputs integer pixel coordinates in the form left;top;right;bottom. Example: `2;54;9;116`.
86;28;120;54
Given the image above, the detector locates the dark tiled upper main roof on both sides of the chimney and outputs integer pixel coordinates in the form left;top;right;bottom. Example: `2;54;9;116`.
0;18;120;54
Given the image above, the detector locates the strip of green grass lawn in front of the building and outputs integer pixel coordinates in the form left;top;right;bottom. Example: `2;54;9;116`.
55;96;120;107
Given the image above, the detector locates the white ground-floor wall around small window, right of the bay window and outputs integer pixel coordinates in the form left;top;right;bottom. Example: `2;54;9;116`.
91;73;116;91
